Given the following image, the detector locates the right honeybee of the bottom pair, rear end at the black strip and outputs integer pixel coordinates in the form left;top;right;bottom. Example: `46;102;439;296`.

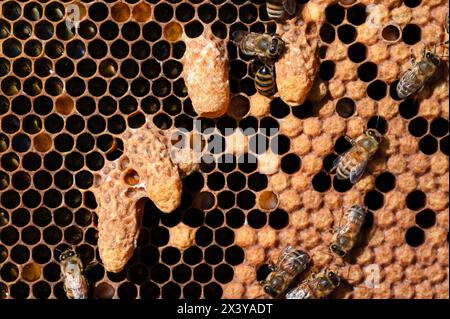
286;270;341;299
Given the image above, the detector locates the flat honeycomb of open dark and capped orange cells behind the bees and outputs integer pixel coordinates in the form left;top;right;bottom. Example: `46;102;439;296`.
0;0;449;299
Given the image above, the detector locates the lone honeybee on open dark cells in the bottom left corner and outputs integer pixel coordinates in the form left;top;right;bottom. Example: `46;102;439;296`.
59;249;89;299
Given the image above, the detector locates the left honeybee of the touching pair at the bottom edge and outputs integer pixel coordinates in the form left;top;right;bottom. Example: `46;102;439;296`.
261;246;311;298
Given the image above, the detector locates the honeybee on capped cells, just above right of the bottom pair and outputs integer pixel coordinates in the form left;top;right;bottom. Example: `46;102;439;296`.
330;205;367;257
